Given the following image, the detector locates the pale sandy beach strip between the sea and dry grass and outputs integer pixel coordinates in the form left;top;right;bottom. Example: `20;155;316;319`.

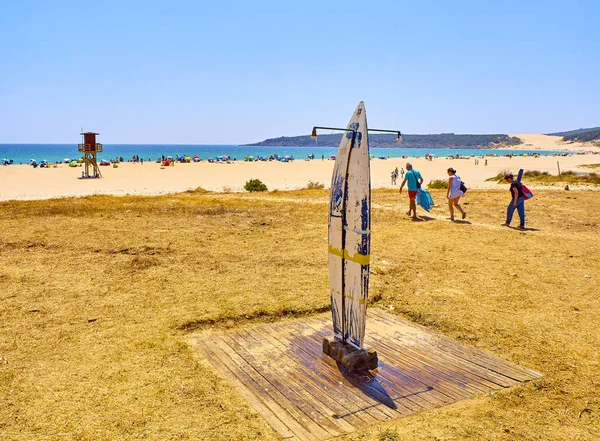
0;149;600;200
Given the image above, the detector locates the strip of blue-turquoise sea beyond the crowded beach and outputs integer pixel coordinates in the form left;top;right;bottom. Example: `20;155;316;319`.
0;144;564;164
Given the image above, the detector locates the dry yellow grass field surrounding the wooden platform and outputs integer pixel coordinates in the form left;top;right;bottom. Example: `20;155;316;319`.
0;190;600;440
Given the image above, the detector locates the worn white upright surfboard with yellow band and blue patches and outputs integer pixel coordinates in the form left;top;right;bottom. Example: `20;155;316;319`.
328;101;371;348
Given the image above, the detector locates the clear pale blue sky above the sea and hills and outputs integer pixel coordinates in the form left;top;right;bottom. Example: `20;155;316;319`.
0;0;600;144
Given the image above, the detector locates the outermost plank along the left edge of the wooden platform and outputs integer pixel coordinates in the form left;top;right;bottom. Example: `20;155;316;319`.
194;338;300;440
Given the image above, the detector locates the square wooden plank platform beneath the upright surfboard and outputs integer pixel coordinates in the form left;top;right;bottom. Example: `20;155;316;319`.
193;308;541;440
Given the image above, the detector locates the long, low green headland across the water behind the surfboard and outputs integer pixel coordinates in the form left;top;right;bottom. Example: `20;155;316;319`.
246;133;521;149
